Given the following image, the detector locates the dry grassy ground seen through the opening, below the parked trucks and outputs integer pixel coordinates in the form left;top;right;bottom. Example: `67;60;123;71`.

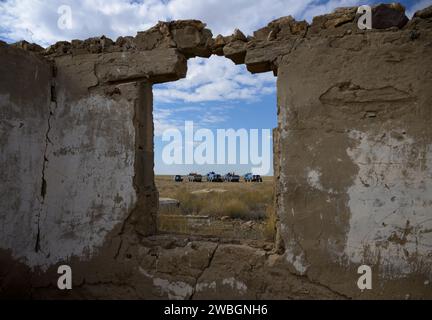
156;176;275;242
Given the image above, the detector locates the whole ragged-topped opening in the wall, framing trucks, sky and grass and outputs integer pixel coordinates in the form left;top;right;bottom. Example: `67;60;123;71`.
153;56;277;243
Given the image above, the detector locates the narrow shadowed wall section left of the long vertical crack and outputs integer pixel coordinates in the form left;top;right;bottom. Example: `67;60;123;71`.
0;46;53;276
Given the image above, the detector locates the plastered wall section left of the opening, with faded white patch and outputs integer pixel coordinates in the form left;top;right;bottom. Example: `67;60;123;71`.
0;46;157;296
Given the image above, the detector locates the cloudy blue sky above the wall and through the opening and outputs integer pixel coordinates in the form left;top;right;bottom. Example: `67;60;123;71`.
0;0;432;174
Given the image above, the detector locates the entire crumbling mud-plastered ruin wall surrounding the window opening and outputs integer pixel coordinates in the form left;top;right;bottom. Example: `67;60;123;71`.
0;5;432;299
